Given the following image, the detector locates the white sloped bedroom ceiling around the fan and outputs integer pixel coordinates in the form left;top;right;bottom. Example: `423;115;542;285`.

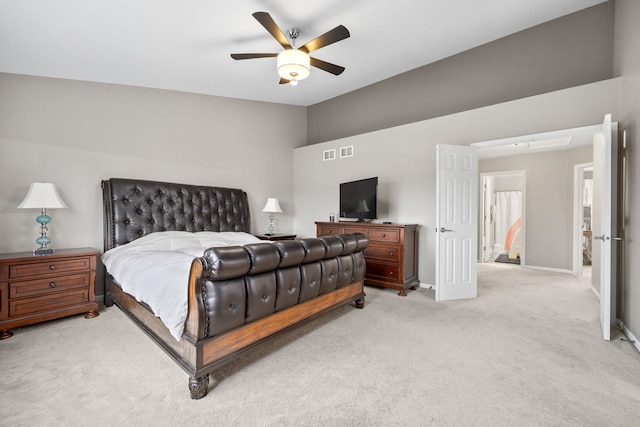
0;0;604;106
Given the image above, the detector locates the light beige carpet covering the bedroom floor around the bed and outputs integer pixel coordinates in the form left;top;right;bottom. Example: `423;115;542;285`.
0;264;640;426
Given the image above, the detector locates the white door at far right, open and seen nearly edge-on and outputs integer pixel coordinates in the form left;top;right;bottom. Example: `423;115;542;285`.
592;114;620;340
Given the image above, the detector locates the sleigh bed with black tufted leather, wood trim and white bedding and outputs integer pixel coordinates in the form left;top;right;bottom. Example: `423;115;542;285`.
102;178;368;399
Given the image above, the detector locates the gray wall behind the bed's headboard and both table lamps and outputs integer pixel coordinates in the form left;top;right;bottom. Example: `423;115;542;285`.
0;74;306;264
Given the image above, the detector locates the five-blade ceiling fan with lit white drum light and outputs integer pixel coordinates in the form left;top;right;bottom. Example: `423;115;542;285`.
231;12;350;86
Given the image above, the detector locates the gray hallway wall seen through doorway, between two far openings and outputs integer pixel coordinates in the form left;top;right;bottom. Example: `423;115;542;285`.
478;146;593;271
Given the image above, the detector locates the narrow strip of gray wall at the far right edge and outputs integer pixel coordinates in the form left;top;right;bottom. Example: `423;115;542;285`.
614;0;640;342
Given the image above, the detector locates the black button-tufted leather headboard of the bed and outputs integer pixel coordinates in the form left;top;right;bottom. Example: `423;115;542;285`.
102;178;251;251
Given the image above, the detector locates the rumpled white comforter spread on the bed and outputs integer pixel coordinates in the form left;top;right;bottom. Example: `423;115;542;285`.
102;231;261;340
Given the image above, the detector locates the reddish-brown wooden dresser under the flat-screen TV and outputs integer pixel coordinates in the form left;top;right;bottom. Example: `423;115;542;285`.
316;222;419;296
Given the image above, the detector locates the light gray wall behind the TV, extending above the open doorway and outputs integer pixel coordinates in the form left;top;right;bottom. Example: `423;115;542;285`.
294;79;620;284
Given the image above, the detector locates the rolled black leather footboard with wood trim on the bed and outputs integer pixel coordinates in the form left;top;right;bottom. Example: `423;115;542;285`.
185;234;368;399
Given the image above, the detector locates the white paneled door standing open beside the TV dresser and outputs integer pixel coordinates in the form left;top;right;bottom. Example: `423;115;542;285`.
436;144;478;301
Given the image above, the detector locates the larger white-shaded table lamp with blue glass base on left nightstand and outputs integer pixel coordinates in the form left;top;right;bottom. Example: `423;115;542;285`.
18;182;67;255
